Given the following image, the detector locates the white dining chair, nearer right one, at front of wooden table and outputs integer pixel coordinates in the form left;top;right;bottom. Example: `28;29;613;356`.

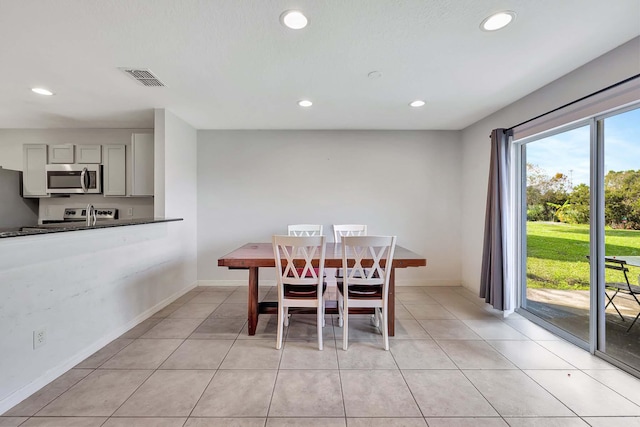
338;236;396;350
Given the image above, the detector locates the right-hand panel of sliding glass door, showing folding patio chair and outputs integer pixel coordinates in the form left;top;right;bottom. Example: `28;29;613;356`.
600;105;640;370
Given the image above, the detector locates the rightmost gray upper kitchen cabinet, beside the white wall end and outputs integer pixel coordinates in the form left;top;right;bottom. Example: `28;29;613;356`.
131;133;154;196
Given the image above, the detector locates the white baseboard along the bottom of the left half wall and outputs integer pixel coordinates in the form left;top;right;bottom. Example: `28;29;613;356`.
0;282;198;415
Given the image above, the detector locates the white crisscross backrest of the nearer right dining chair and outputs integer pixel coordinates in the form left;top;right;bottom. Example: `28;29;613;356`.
342;236;396;290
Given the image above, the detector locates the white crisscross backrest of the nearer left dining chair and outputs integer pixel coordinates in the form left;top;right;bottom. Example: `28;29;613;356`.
273;235;325;288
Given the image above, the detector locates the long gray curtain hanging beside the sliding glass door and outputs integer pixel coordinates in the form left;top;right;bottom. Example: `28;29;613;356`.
480;129;511;310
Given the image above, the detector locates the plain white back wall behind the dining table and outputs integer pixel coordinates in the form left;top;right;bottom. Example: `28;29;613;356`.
198;131;461;285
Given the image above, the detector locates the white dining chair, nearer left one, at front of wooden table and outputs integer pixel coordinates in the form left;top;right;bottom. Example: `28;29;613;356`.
273;236;327;350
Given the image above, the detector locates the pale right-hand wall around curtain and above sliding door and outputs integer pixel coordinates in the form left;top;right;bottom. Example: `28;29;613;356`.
461;38;640;291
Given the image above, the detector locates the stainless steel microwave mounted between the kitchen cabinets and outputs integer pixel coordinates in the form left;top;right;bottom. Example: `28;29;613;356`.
46;164;102;194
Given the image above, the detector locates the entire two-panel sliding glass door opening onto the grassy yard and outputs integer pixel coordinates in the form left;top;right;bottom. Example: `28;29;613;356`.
516;105;640;373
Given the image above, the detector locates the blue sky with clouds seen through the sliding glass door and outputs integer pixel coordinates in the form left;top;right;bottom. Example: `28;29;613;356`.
527;108;640;186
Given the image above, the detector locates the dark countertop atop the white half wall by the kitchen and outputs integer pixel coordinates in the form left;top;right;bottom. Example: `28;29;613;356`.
0;218;182;239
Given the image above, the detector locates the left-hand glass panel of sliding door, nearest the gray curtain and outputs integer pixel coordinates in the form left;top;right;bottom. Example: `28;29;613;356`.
522;124;591;341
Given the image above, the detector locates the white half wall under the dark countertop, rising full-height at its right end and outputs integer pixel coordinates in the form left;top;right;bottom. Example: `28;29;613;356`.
0;111;197;414
